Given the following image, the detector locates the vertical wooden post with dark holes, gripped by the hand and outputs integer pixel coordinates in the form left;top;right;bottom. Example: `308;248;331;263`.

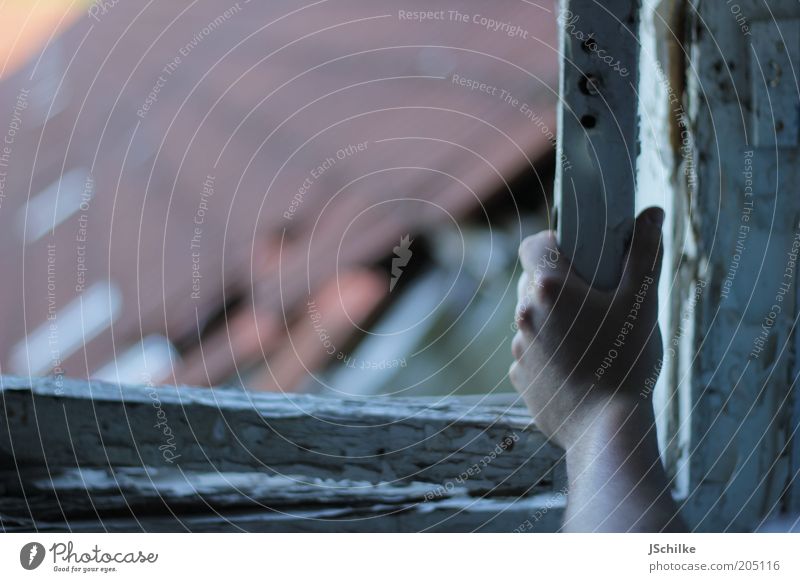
555;0;641;289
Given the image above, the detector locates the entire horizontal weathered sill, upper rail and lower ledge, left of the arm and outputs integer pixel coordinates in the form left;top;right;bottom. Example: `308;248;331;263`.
0;376;565;531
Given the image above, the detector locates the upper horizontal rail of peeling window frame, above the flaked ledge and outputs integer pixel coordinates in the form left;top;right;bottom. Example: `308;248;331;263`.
0;377;562;494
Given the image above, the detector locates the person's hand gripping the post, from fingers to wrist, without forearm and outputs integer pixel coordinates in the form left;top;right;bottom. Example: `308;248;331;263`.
509;208;664;450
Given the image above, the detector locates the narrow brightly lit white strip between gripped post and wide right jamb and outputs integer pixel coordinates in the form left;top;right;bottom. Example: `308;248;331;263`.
636;0;696;496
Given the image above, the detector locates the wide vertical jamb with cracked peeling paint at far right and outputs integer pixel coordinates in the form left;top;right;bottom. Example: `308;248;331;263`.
681;0;800;531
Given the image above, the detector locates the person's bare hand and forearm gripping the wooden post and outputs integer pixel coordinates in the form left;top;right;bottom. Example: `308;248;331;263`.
509;208;685;532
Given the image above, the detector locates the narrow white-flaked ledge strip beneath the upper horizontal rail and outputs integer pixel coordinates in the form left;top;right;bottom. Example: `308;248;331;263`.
0;468;438;521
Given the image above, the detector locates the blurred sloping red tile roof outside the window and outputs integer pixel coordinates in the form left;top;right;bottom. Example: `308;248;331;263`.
0;0;557;389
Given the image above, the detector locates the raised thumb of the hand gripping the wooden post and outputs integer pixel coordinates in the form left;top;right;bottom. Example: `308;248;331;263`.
622;207;664;291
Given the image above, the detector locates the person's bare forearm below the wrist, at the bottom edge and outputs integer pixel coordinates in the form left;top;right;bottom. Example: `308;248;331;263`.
564;401;685;532
